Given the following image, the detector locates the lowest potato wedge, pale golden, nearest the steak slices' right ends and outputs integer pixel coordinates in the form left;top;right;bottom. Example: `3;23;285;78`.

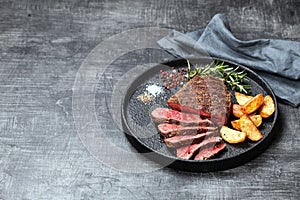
220;126;246;144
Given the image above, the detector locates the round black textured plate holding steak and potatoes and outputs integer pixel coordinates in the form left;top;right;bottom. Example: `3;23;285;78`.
122;58;278;172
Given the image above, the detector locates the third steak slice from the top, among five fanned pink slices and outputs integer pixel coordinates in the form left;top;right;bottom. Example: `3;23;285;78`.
164;131;218;148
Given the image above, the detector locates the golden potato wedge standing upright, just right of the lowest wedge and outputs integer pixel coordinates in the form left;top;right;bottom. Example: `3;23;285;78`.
240;115;263;142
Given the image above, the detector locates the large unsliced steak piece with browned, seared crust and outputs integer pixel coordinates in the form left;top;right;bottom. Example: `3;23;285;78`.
167;76;231;125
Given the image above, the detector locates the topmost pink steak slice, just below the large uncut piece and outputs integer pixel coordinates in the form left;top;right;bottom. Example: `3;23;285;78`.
151;108;212;126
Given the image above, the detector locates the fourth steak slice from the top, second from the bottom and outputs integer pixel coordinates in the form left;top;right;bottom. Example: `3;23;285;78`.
177;137;222;159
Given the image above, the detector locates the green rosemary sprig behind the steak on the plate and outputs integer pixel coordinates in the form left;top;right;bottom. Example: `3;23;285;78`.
186;60;251;94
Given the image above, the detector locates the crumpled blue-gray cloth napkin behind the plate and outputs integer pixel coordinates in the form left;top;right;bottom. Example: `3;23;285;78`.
157;14;300;107
